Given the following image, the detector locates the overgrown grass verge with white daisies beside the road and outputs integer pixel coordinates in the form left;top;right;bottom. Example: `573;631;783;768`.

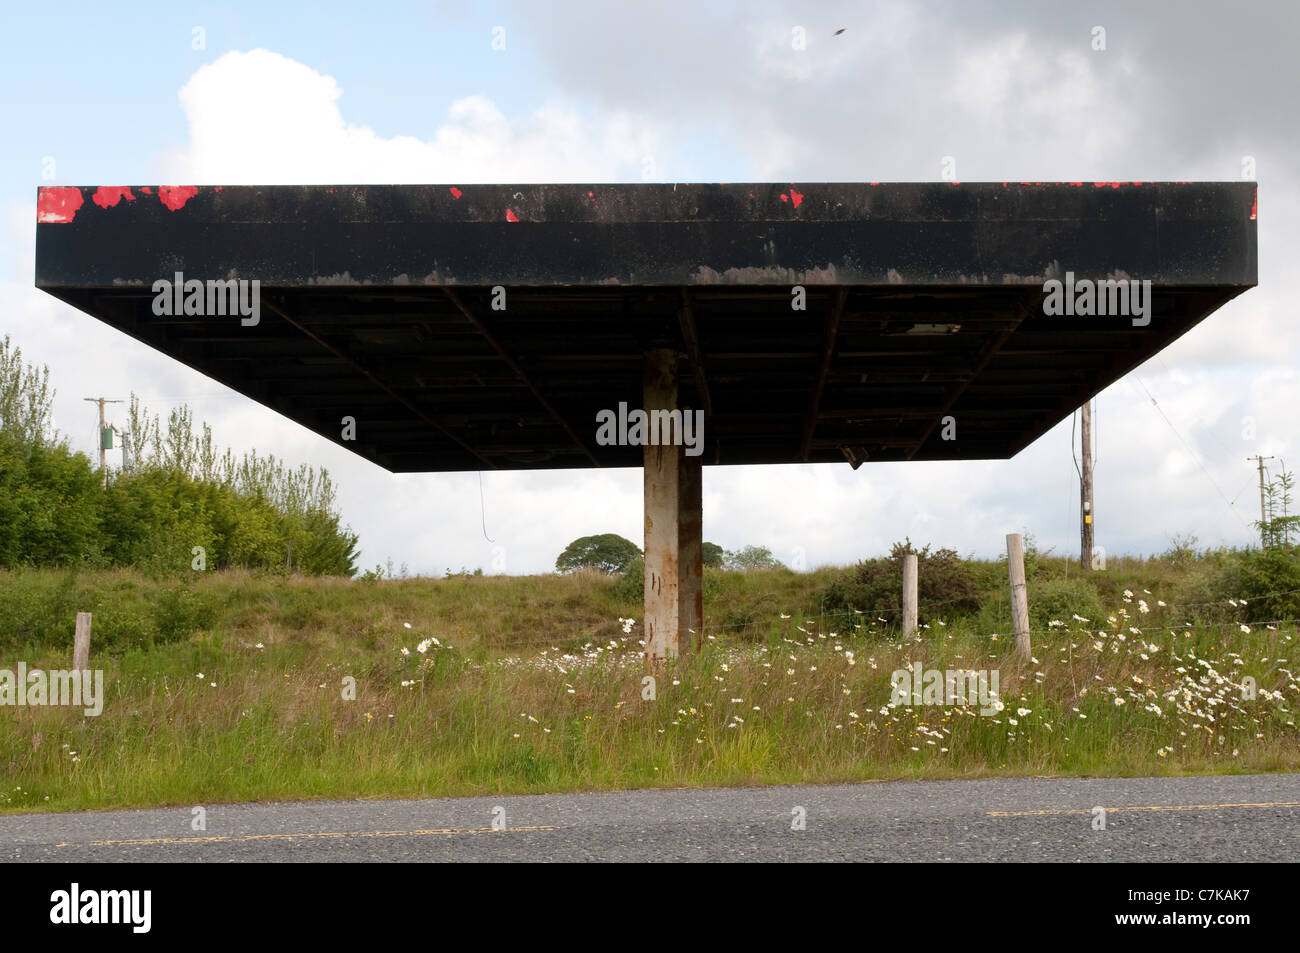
0;560;1300;811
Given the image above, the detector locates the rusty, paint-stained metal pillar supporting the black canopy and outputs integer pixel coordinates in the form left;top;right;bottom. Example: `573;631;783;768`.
644;348;703;668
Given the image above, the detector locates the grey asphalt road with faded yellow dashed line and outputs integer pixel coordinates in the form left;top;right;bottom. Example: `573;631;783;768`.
0;774;1300;863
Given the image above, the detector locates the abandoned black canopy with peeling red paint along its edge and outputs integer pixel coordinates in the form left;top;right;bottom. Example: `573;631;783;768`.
36;182;1257;472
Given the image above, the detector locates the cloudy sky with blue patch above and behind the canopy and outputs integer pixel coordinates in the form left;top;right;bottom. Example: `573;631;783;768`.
0;0;1300;575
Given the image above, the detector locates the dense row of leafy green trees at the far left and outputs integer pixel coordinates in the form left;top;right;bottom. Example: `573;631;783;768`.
0;337;358;576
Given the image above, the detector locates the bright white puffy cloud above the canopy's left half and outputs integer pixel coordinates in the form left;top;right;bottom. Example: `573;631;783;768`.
160;49;657;185
